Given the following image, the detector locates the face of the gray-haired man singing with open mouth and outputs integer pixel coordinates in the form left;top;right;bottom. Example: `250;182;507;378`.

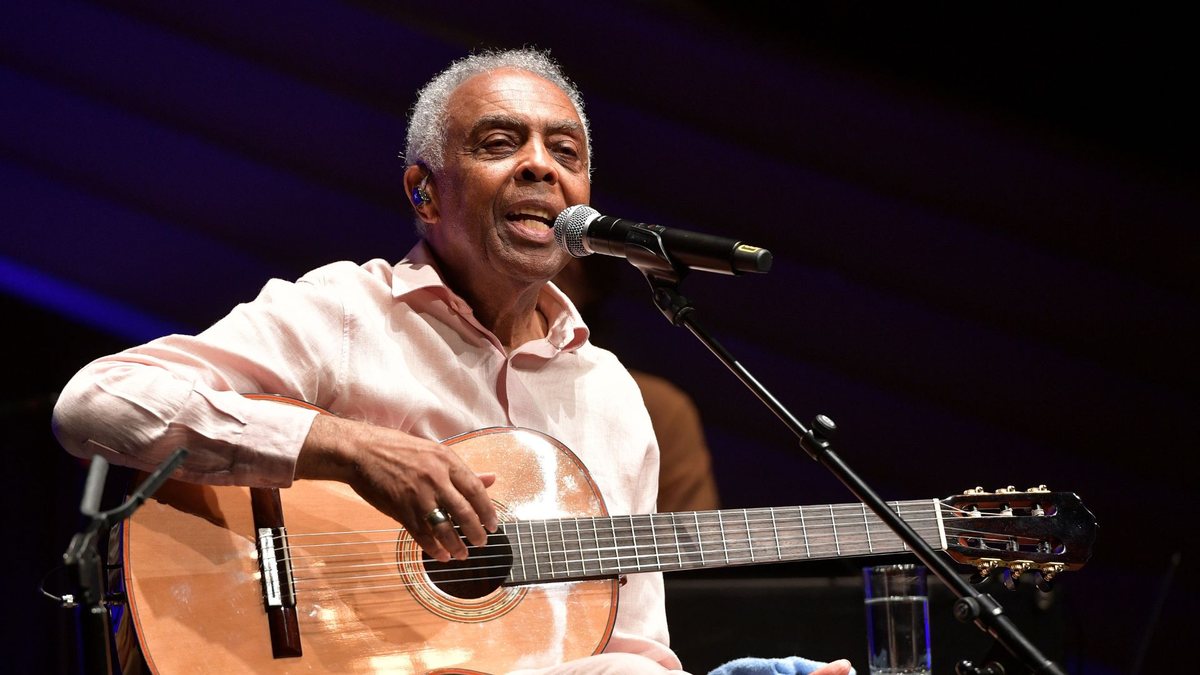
427;70;590;293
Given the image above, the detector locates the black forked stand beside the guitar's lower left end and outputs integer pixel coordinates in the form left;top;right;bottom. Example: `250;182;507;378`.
62;448;187;675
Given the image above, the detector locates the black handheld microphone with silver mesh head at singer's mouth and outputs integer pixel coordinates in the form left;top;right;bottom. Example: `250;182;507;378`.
554;204;770;274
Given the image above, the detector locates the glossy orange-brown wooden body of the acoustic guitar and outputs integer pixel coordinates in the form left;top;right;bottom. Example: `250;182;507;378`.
124;429;618;674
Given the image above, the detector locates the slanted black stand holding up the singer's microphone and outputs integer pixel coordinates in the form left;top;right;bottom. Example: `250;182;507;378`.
625;240;1066;675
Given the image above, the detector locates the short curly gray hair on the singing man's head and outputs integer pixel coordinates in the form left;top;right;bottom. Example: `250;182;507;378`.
404;48;592;174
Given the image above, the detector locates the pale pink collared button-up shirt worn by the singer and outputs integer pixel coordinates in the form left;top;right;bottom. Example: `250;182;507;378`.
54;243;679;670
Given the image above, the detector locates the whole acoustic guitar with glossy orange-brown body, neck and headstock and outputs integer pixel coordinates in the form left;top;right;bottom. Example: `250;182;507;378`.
122;413;1096;674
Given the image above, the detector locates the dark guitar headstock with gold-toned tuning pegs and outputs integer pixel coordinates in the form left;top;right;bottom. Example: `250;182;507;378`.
942;485;1098;581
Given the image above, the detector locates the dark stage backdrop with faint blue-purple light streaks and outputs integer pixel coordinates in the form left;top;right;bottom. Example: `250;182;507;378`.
0;0;1200;674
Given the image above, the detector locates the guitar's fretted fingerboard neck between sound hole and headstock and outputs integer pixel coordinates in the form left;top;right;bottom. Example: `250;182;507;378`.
503;500;946;585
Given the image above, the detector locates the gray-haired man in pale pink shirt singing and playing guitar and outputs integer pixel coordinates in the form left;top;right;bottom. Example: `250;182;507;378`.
54;50;848;674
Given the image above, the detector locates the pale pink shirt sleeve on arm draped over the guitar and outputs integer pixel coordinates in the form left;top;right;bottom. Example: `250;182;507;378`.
53;271;346;486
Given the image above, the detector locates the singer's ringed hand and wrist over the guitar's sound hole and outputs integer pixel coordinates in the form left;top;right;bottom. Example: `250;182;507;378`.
295;414;499;562
